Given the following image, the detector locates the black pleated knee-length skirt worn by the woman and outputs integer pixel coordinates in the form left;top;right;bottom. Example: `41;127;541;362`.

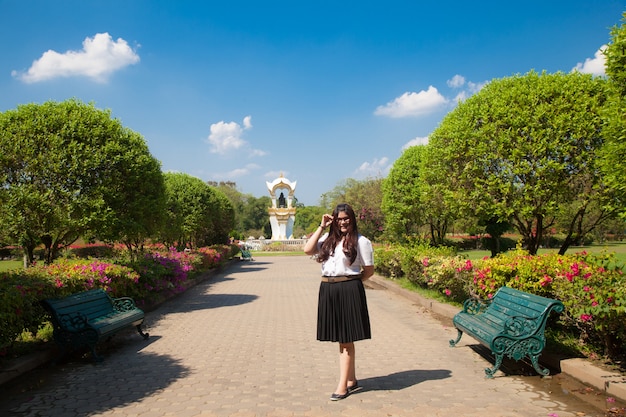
317;279;372;343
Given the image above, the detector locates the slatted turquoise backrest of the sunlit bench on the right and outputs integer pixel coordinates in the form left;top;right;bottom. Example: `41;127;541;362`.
483;287;563;333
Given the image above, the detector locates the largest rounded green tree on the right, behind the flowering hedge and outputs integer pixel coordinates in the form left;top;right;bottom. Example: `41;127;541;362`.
429;71;609;254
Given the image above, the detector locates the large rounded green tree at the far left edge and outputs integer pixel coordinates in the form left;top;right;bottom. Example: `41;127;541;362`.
0;100;160;263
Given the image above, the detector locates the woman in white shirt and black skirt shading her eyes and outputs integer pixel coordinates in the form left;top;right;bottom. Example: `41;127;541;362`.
304;204;374;401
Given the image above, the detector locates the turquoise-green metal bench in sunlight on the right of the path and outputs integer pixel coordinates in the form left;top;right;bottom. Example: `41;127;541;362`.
450;287;564;378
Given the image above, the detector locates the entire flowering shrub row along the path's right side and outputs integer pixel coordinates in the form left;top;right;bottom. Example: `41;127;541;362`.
375;247;626;359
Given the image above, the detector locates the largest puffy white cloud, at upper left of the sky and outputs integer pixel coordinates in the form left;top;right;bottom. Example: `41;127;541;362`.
11;33;139;83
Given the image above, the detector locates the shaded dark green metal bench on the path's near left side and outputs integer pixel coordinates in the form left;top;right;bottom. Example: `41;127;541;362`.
42;289;149;361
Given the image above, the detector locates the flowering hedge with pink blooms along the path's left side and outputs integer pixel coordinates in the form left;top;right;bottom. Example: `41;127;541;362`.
0;245;232;355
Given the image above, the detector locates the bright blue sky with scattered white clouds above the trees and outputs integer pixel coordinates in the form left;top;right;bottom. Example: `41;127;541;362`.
0;0;626;205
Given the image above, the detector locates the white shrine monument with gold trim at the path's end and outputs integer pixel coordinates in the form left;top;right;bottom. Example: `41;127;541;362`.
265;173;297;240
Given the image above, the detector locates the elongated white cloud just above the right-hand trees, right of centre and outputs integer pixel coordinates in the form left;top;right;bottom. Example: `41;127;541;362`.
374;85;448;118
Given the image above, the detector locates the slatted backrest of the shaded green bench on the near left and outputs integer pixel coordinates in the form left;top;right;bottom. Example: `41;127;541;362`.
44;289;114;320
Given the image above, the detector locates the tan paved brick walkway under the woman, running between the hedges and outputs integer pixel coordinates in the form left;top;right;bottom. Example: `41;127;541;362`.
0;256;616;417
